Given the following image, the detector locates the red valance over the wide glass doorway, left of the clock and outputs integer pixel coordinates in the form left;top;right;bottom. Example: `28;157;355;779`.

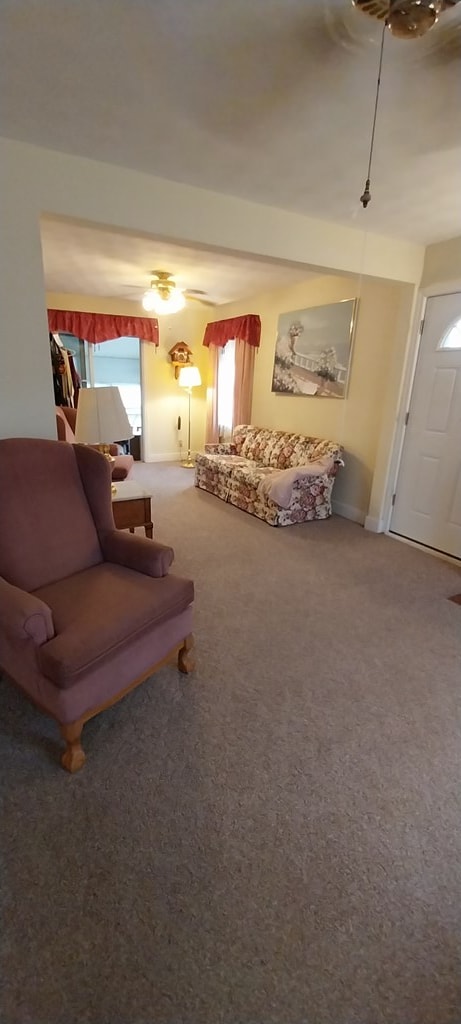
48;309;159;345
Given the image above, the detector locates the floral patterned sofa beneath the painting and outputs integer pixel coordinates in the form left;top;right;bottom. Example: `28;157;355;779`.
195;425;342;526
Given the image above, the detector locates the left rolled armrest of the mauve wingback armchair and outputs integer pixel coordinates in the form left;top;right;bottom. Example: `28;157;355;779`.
0;577;54;646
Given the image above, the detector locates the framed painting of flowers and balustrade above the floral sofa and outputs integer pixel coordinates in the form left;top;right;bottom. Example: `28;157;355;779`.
273;299;358;398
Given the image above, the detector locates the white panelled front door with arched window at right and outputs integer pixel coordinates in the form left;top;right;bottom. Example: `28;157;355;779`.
390;292;461;558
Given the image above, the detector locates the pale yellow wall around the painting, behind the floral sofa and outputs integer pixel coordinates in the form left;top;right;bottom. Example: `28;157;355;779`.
211;276;412;522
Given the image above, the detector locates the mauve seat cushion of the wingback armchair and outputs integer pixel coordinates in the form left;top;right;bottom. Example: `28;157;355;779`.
35;562;194;689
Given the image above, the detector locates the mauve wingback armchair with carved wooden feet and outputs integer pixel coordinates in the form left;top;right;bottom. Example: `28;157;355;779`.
0;437;194;772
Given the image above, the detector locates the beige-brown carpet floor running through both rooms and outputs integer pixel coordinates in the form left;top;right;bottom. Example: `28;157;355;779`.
0;465;461;1024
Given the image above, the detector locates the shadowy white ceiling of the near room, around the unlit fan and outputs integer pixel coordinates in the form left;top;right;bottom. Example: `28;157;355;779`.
0;0;461;243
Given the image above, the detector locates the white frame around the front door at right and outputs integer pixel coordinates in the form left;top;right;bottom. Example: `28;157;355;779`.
384;281;461;552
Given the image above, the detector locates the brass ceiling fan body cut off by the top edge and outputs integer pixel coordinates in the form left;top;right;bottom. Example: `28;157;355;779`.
352;0;459;39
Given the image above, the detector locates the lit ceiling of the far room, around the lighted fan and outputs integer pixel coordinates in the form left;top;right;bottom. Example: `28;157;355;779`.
41;217;315;305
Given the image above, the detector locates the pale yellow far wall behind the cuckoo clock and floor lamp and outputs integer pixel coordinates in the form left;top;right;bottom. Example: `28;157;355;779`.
46;293;209;462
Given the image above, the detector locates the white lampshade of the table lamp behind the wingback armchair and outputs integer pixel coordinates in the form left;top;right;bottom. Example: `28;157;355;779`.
75;387;133;444
